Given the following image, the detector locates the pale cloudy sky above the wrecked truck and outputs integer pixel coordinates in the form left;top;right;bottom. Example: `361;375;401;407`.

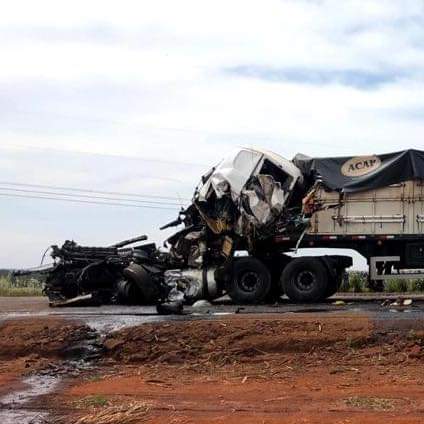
0;0;424;267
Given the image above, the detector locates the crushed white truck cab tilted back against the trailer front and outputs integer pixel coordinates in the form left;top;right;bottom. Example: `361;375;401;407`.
194;148;303;237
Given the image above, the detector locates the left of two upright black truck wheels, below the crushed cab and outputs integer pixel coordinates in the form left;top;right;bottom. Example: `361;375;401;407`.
227;257;271;304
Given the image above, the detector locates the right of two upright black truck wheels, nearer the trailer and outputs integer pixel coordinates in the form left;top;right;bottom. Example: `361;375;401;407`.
281;257;328;302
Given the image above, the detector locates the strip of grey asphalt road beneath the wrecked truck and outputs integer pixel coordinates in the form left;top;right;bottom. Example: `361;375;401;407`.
0;294;424;333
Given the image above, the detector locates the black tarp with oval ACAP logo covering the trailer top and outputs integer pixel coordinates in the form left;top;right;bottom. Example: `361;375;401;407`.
293;149;424;193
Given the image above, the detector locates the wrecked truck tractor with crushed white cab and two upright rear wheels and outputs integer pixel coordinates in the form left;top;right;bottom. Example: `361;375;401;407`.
163;148;352;304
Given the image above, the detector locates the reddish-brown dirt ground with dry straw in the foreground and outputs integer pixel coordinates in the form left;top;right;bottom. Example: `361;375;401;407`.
0;314;424;424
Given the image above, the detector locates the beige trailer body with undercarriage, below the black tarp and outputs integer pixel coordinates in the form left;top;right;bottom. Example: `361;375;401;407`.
274;180;424;291
